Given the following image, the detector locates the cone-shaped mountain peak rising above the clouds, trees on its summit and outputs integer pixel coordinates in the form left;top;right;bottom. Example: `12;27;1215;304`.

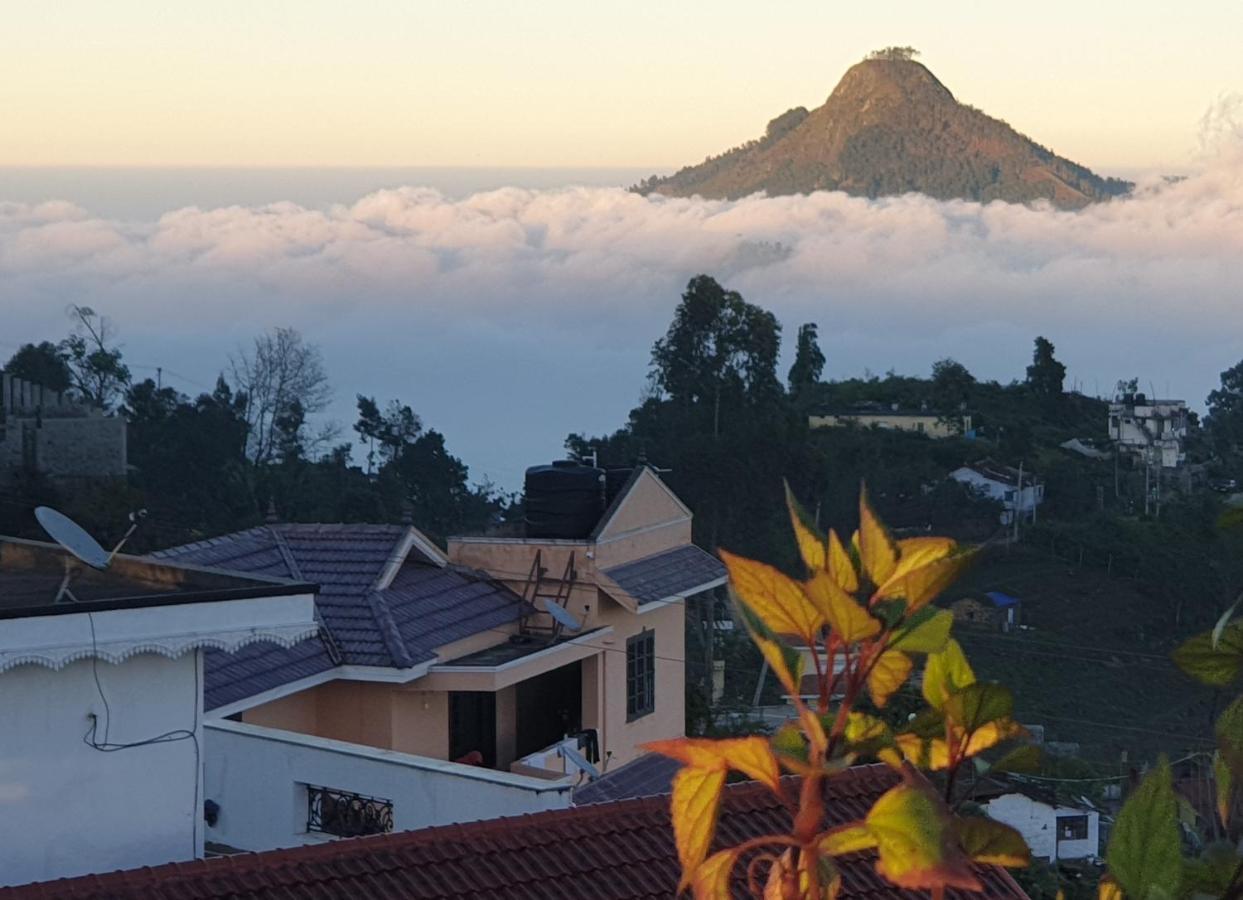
634;48;1131;209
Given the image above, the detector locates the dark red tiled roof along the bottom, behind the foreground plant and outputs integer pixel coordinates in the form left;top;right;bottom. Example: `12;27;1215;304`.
0;766;1025;900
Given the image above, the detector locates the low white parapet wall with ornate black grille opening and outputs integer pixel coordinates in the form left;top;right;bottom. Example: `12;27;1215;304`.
204;721;572;850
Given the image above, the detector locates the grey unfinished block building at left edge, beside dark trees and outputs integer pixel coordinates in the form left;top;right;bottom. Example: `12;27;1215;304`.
0;373;127;484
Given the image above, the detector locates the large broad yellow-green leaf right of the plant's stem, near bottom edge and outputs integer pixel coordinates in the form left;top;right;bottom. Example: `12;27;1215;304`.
866;783;981;890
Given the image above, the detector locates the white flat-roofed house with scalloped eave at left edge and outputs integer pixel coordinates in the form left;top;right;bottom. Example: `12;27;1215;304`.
0;537;317;885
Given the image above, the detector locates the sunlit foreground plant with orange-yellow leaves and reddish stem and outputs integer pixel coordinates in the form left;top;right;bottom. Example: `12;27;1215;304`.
648;487;1029;900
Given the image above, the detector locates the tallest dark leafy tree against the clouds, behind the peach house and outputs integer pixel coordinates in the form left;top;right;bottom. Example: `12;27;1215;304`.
650;275;782;434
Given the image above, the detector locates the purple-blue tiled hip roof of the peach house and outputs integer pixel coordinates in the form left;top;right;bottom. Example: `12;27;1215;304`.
153;525;522;710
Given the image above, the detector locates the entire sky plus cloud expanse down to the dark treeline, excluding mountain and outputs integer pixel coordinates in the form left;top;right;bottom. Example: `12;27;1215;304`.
0;0;1243;490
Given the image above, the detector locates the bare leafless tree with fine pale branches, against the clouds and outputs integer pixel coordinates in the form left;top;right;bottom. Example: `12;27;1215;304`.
230;328;332;466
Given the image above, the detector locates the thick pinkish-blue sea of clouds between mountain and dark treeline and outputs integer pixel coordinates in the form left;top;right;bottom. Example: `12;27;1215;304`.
0;149;1243;487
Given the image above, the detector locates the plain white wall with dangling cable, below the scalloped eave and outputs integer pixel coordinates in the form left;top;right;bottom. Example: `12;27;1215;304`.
0;651;203;885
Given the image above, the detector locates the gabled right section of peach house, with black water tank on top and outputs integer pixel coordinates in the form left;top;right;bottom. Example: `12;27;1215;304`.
447;462;726;766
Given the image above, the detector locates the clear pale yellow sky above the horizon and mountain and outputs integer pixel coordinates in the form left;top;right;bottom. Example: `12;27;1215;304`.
0;0;1243;174
